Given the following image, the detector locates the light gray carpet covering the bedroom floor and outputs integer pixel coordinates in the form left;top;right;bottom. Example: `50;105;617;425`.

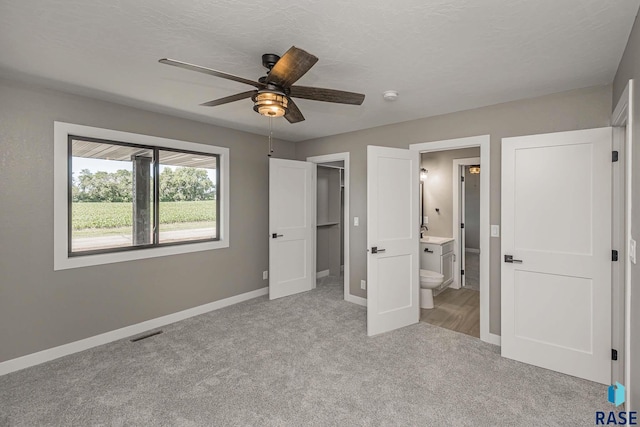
0;283;610;426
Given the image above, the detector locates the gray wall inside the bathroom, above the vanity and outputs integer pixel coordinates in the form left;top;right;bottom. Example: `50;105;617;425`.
421;148;480;237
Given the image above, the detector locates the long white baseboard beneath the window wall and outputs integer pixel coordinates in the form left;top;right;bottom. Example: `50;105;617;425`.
0;287;269;376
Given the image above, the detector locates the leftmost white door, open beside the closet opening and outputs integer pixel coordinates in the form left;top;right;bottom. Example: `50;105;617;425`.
269;159;316;299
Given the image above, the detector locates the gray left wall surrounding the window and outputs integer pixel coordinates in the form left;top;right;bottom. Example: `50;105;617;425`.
0;80;295;362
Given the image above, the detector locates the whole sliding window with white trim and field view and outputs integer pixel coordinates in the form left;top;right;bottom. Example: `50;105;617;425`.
54;122;229;270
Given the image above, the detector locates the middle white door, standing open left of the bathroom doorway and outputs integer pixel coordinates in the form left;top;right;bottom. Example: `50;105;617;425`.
367;146;420;336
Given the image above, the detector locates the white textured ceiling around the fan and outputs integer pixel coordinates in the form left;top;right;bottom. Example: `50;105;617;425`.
0;0;640;141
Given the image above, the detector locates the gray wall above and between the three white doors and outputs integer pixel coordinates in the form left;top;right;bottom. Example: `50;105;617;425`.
296;86;608;334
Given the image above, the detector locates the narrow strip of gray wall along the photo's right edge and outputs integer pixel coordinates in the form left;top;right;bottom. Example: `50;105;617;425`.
613;11;640;411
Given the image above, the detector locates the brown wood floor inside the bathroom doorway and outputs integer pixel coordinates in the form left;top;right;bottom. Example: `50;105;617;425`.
420;288;480;338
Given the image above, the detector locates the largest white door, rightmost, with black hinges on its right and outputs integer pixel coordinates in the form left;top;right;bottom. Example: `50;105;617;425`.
501;128;612;384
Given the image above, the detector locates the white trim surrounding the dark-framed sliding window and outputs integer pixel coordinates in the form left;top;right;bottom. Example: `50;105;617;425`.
53;121;229;270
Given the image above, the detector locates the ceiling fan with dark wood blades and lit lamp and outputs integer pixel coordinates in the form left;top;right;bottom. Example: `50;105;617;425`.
160;46;364;123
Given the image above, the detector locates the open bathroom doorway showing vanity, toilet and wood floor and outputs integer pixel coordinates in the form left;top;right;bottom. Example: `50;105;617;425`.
420;147;480;338
